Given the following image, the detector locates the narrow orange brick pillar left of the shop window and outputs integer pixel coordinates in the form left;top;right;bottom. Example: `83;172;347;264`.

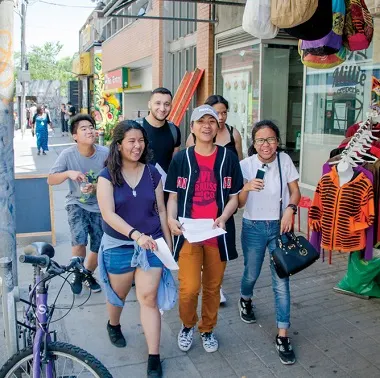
197;4;214;105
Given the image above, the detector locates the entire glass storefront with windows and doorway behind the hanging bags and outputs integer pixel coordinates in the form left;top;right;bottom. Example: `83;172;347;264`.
215;25;380;197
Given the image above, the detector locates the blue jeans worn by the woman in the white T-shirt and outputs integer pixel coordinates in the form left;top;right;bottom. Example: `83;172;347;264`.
240;218;290;329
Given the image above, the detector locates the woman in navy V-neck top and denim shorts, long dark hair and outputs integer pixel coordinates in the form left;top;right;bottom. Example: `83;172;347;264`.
97;121;172;377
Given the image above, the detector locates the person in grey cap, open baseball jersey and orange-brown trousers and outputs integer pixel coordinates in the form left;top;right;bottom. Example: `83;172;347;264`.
165;105;243;352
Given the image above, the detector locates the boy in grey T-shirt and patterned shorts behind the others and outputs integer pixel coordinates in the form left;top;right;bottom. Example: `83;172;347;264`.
48;114;108;294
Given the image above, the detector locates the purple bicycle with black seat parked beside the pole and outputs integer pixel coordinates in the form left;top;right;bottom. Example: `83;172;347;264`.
0;243;112;378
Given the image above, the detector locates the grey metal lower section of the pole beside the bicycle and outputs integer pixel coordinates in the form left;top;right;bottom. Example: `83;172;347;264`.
0;255;18;357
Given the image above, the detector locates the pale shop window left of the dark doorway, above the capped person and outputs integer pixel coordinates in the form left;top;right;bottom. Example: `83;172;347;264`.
216;45;260;153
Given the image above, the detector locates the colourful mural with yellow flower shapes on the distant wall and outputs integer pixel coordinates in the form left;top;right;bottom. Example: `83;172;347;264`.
91;52;122;139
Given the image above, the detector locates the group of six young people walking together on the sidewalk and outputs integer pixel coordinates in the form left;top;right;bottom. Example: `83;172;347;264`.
48;88;300;377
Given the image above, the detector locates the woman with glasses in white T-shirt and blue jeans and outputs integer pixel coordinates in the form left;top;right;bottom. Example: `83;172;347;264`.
238;120;301;365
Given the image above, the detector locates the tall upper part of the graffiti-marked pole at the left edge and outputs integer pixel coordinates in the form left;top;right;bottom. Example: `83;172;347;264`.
0;0;17;286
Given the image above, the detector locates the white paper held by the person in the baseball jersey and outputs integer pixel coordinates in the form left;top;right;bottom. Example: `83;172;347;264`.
178;217;227;243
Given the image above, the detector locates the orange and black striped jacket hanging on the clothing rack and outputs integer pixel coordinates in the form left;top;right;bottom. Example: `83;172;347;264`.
309;167;375;252
